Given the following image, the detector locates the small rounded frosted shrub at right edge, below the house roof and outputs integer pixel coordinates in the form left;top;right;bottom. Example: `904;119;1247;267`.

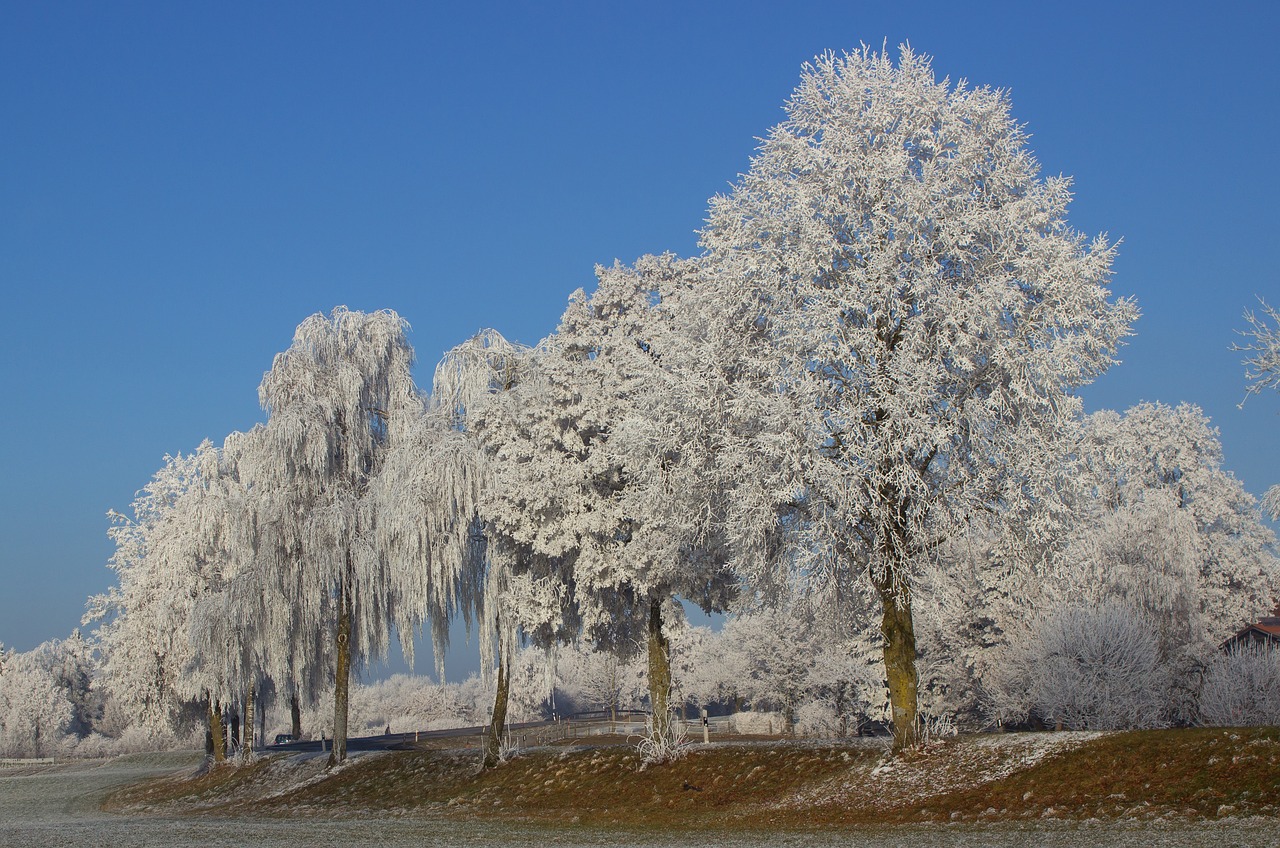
1199;646;1280;728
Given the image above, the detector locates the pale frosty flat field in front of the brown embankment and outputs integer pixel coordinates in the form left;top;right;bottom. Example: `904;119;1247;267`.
0;754;1280;848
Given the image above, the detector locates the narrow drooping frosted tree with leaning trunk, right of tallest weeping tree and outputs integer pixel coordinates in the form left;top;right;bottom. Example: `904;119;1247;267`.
414;330;576;769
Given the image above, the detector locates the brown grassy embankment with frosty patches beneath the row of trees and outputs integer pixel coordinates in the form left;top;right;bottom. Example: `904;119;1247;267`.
97;728;1280;830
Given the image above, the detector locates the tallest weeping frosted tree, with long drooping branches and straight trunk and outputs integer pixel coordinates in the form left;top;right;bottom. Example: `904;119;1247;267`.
255;307;422;763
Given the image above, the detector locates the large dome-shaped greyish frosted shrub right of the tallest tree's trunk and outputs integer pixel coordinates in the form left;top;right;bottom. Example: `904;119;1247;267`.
987;602;1170;730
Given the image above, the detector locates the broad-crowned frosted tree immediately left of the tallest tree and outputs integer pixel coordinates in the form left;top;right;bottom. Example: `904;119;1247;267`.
471;256;735;747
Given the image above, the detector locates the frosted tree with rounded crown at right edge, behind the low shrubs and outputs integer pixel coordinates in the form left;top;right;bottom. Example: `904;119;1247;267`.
1051;404;1280;691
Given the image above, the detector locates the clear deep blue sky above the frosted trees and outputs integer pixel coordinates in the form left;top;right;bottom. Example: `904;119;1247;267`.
0;0;1280;667
